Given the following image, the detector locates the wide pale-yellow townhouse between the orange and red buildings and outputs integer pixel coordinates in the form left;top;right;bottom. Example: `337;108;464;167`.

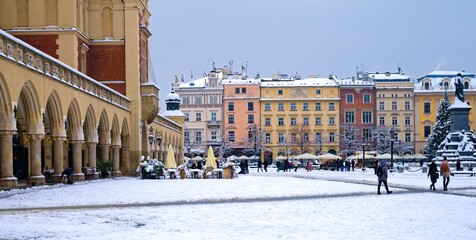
260;75;340;161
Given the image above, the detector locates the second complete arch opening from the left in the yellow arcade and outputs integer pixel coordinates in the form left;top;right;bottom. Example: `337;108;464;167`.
44;90;66;137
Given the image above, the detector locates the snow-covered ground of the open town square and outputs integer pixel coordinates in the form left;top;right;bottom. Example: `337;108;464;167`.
0;169;476;240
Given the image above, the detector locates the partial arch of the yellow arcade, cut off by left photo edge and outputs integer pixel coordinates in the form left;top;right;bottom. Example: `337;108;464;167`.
0;73;16;130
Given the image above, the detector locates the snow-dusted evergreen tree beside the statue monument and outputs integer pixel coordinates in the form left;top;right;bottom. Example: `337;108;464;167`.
424;93;451;156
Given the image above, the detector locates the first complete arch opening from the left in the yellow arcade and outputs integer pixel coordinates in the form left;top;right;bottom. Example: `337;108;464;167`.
17;81;44;134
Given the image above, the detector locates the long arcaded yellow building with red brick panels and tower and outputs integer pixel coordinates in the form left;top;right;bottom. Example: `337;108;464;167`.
0;0;183;189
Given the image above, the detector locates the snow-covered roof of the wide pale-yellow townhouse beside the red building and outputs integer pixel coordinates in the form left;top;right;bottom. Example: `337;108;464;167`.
261;78;338;87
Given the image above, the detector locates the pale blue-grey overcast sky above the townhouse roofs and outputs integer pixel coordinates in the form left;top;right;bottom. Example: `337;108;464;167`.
149;0;476;111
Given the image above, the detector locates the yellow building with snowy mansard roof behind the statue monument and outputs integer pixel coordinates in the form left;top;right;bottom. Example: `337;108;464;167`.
414;71;476;153
